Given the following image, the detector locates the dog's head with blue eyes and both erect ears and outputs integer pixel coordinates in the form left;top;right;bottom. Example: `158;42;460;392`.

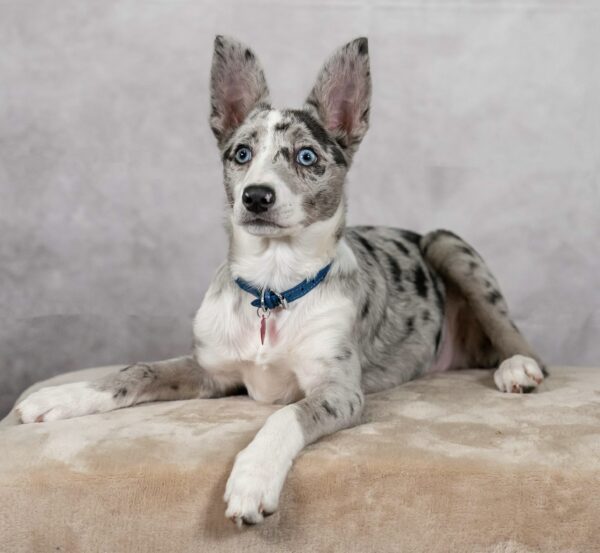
210;36;371;236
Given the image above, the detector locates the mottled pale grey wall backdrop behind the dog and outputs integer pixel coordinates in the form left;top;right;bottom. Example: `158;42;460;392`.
0;0;600;413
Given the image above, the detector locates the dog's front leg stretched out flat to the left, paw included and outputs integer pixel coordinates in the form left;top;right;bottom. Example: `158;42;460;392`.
16;356;235;423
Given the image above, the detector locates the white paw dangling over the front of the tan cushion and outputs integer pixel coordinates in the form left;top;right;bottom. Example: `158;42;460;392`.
224;446;287;528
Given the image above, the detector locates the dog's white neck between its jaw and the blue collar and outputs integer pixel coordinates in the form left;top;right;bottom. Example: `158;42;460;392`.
229;202;345;292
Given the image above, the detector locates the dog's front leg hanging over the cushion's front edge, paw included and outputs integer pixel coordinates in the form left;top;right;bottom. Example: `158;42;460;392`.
225;382;364;527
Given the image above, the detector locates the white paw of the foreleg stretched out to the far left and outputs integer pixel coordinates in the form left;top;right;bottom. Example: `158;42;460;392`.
15;382;116;423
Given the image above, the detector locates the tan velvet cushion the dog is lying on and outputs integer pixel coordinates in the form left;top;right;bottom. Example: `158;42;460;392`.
0;367;600;553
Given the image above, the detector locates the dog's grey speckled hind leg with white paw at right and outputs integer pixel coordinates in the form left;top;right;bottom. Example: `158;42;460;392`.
421;230;547;392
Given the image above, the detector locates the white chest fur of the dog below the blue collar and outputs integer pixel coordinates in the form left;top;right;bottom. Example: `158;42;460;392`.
194;272;354;403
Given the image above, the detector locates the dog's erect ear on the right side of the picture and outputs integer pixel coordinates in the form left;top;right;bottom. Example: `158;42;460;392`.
306;37;371;151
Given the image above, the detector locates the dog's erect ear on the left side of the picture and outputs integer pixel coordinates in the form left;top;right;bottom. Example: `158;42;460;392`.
210;35;269;145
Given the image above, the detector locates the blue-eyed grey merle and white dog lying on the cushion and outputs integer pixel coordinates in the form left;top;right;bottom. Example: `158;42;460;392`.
16;36;547;527
